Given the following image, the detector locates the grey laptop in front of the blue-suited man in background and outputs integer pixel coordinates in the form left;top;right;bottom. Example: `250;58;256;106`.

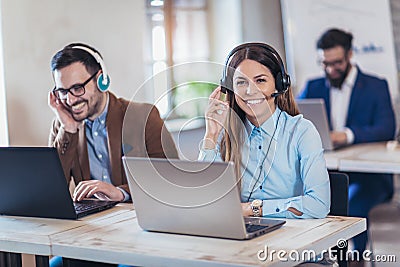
296;98;338;150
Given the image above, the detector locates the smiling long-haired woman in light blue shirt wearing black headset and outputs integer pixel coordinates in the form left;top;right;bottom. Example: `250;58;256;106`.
199;43;330;218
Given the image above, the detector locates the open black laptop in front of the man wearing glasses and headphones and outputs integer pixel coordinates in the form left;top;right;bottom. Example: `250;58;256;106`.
0;147;118;219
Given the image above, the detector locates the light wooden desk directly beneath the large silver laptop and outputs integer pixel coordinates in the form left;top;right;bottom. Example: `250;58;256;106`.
51;204;366;266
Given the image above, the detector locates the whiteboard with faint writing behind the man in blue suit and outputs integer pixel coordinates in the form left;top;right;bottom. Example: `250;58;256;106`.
281;0;398;102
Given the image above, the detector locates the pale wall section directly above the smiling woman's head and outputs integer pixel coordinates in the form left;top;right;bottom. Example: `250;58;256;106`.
208;0;285;66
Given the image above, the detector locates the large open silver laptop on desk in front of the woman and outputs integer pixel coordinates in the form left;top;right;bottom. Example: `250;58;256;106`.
123;157;285;242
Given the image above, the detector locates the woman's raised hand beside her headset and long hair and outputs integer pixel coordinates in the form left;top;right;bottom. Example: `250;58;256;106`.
203;86;229;149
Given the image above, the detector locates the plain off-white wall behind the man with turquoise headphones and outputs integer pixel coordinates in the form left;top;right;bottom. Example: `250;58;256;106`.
1;0;145;146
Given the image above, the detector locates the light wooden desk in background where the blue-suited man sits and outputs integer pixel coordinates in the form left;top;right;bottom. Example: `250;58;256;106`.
324;142;400;174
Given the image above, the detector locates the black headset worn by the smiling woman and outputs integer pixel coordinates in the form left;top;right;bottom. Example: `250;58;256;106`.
220;42;290;97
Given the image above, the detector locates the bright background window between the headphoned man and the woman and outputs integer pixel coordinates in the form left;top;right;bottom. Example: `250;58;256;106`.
146;0;216;118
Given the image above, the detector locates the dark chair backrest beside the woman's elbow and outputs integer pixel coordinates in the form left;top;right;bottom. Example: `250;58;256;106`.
329;172;349;216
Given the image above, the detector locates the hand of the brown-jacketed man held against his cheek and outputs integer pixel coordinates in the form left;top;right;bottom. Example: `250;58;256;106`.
48;91;81;133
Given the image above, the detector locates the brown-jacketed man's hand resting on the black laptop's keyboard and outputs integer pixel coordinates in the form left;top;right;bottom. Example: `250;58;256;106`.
73;180;124;201
